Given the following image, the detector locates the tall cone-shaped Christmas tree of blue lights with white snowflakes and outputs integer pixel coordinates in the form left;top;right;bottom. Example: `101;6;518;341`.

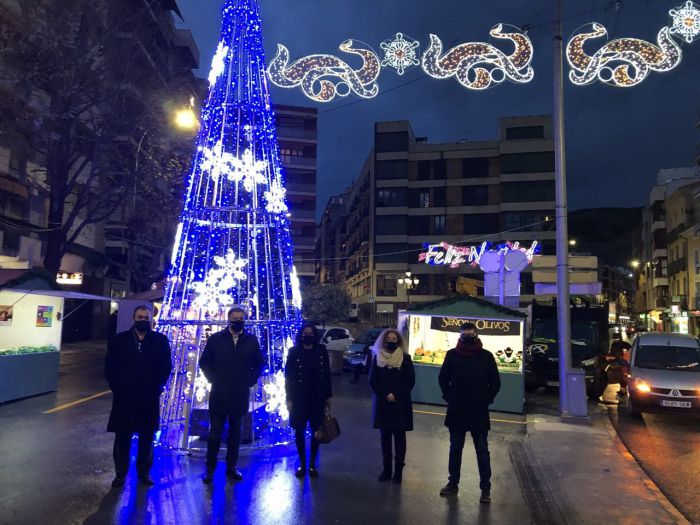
158;0;301;448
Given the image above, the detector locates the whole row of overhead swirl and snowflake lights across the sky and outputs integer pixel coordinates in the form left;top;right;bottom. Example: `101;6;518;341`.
266;0;700;103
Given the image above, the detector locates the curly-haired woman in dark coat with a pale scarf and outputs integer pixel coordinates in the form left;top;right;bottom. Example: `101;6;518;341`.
369;329;416;484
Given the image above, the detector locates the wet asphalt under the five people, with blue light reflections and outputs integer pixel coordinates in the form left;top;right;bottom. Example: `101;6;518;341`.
0;343;531;525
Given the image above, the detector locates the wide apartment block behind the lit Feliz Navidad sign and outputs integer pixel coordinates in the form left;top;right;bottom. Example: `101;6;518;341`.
330;116;555;320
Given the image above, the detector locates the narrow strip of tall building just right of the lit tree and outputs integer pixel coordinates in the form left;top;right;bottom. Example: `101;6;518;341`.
275;104;318;283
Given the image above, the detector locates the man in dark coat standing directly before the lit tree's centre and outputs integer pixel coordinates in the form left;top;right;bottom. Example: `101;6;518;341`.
199;307;264;483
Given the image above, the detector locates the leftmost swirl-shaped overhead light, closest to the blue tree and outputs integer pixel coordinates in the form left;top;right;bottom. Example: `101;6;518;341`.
267;40;382;102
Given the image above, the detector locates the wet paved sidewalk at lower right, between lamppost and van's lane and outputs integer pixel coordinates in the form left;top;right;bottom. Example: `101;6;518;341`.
514;408;689;524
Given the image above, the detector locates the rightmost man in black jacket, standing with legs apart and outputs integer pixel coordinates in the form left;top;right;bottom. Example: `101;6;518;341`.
439;323;501;503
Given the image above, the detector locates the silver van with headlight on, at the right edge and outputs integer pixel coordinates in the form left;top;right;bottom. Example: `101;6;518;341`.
627;332;700;417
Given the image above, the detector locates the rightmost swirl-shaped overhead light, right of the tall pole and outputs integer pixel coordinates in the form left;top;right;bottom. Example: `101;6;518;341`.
566;22;682;87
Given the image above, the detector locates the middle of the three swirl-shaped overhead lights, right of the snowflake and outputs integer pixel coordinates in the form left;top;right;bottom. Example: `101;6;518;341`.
422;24;535;90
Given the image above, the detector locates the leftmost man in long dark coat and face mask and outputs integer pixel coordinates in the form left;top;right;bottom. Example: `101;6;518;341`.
105;306;172;487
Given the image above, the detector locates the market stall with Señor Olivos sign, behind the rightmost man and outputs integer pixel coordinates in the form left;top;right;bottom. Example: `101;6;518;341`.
398;296;527;414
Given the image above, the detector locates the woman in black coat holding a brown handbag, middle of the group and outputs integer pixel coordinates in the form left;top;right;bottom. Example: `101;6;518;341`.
285;323;333;478
